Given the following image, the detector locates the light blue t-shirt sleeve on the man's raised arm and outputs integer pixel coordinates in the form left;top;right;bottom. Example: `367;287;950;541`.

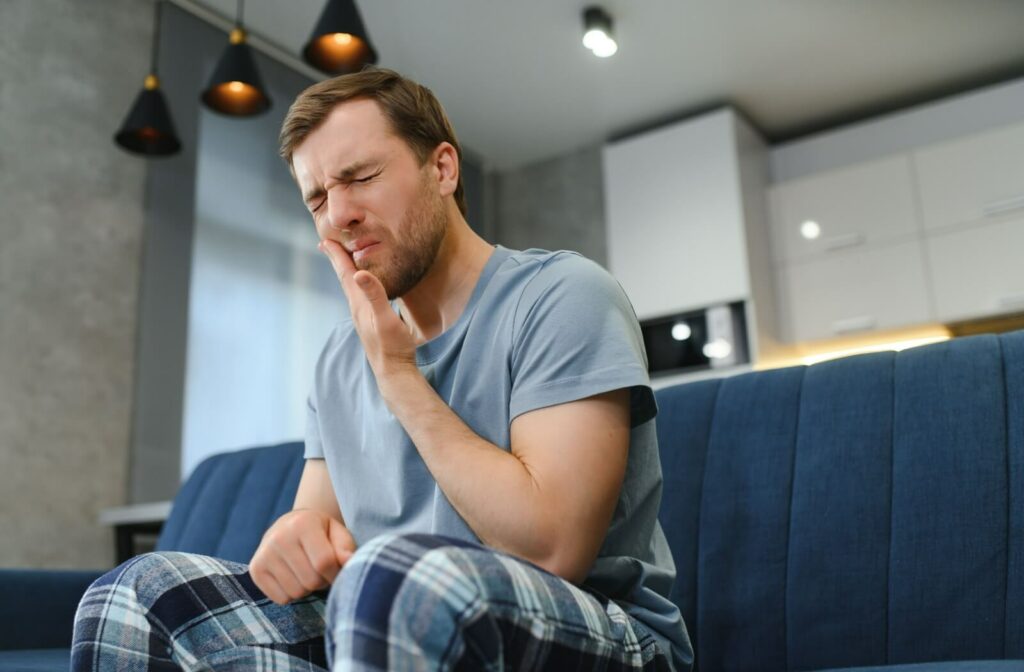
509;253;657;427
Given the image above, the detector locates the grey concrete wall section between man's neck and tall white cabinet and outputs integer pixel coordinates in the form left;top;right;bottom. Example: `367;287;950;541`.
486;145;608;264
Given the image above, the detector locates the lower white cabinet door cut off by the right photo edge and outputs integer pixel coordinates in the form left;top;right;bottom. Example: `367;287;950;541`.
928;218;1024;321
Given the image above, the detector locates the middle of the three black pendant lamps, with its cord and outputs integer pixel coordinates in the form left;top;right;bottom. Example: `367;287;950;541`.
200;0;270;117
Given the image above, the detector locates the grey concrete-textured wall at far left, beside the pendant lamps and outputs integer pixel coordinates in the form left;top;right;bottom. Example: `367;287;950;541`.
0;0;153;568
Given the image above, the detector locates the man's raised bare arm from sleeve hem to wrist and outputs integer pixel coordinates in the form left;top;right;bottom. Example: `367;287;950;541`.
381;375;630;583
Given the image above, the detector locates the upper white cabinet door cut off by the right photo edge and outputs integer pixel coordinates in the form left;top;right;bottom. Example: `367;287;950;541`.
913;124;1024;229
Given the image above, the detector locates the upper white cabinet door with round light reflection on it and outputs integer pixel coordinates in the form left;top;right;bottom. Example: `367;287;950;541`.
770;155;920;261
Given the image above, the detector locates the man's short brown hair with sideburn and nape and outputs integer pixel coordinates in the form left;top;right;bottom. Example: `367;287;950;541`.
279;68;466;216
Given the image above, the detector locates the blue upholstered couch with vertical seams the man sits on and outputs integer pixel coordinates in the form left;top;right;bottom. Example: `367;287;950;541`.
0;331;1024;672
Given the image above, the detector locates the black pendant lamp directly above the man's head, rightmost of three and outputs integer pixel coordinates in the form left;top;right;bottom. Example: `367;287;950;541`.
302;0;377;75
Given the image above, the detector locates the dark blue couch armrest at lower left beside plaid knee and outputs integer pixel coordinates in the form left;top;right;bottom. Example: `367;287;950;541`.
0;570;103;650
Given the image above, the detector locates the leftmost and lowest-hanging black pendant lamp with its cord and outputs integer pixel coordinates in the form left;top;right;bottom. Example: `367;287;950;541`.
114;0;181;157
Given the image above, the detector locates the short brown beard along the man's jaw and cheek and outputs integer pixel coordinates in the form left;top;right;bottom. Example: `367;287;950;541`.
355;174;447;301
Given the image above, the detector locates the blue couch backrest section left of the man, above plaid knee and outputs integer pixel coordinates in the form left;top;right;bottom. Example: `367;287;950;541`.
151;442;303;562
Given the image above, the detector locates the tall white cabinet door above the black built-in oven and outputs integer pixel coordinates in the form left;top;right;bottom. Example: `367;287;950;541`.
603;112;750;320
